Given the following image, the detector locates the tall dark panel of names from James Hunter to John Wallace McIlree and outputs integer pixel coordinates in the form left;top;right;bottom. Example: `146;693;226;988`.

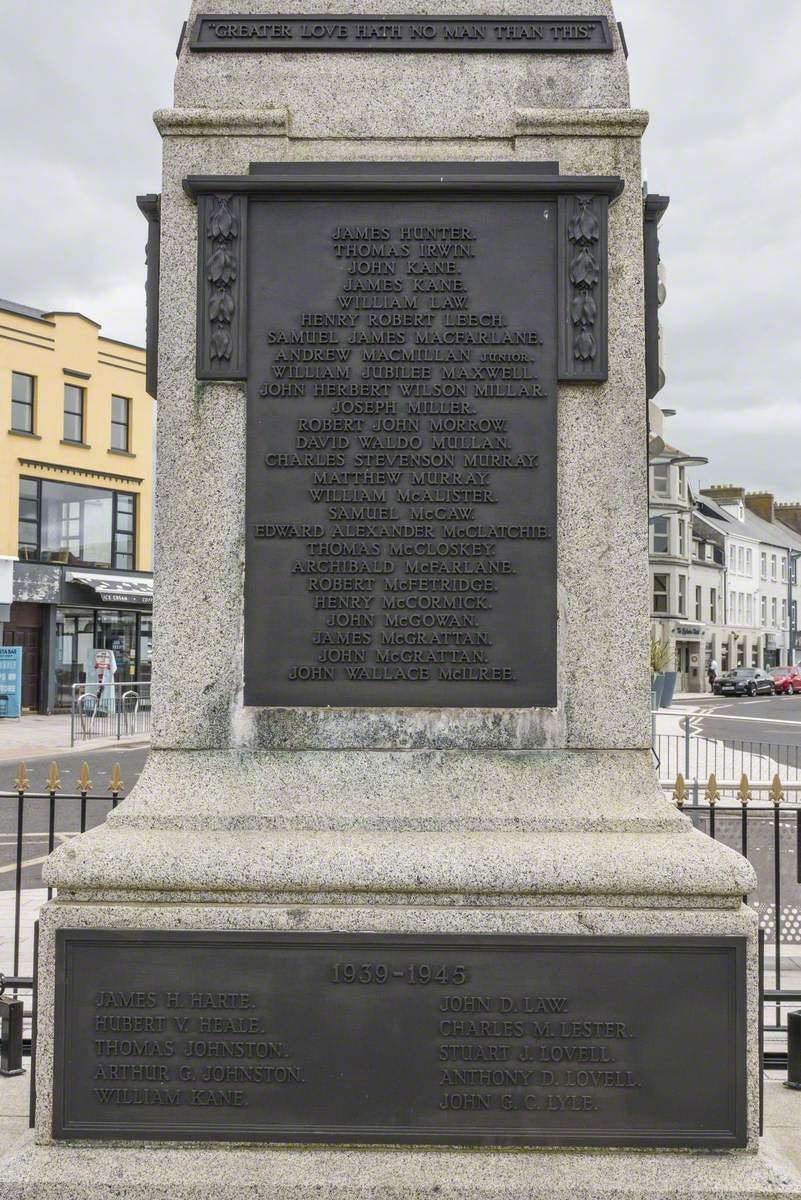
246;195;556;707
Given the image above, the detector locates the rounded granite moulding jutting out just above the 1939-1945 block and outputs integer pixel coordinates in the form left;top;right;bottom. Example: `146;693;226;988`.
42;827;755;904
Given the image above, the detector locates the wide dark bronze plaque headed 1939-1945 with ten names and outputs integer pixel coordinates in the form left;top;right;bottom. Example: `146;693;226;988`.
53;930;746;1148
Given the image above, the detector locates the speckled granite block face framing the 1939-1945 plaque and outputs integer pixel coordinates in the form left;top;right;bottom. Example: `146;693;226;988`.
28;896;759;1152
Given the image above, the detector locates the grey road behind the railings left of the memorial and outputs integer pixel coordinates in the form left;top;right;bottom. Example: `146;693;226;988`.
0;745;149;892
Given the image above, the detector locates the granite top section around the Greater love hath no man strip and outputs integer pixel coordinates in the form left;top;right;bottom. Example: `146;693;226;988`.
175;0;628;139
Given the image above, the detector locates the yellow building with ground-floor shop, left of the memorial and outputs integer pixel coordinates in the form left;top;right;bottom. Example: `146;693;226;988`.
0;300;155;712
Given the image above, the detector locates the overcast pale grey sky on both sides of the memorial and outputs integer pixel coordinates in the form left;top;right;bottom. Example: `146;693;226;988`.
0;0;801;499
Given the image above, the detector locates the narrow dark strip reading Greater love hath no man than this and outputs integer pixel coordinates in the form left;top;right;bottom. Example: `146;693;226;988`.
189;13;613;54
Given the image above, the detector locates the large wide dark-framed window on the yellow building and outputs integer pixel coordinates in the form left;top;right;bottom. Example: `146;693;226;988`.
19;478;135;570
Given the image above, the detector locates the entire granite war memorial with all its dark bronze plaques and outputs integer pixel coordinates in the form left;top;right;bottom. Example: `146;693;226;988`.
0;0;801;1200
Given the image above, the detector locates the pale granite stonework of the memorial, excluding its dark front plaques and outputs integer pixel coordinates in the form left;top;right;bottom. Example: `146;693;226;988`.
0;0;801;1200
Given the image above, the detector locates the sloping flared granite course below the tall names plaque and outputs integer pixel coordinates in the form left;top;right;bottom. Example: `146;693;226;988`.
108;750;682;833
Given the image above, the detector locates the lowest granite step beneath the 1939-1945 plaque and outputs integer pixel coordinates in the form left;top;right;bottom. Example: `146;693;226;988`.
0;1138;801;1200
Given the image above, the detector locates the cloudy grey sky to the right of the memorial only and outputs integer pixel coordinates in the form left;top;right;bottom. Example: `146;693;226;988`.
616;0;801;499
